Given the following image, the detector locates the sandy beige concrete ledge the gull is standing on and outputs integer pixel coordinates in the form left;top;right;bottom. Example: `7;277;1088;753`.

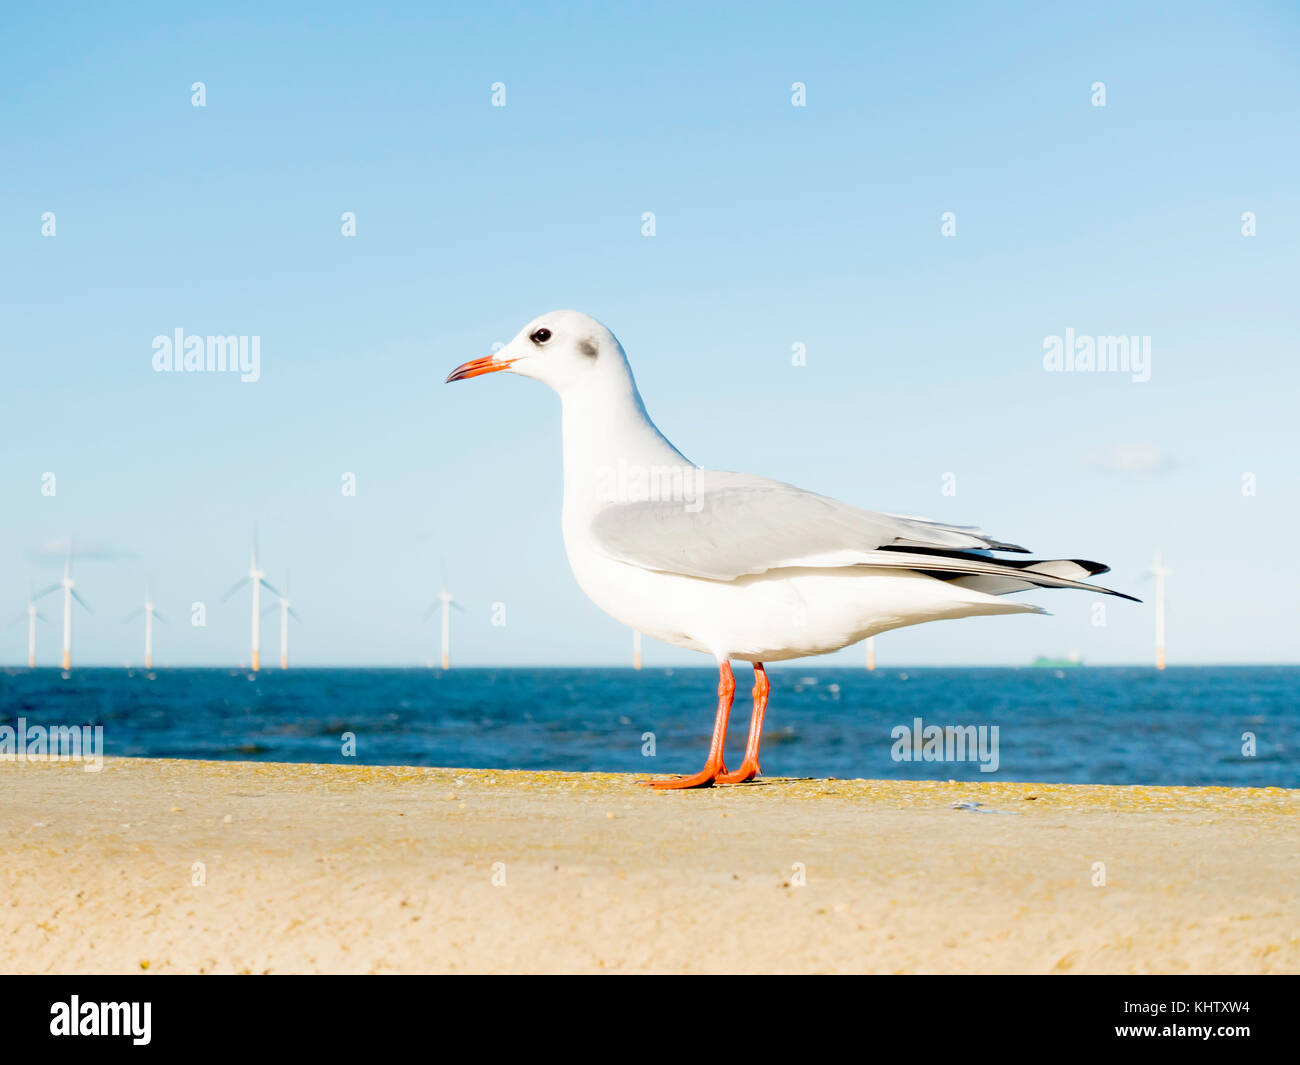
0;759;1300;973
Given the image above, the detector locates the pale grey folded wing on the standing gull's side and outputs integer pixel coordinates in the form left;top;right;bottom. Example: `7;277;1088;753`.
592;469;1024;580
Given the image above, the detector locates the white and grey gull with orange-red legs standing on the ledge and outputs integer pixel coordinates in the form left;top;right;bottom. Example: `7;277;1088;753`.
447;311;1139;789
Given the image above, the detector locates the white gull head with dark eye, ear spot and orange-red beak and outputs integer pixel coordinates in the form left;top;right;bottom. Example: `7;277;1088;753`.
447;311;628;395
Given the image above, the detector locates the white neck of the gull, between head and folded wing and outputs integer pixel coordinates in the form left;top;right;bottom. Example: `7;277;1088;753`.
562;380;693;507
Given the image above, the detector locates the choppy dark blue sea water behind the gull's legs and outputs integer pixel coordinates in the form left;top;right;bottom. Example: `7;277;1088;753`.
0;666;1300;788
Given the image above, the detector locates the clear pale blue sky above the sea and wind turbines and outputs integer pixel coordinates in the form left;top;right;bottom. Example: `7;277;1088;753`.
0;4;1300;664
